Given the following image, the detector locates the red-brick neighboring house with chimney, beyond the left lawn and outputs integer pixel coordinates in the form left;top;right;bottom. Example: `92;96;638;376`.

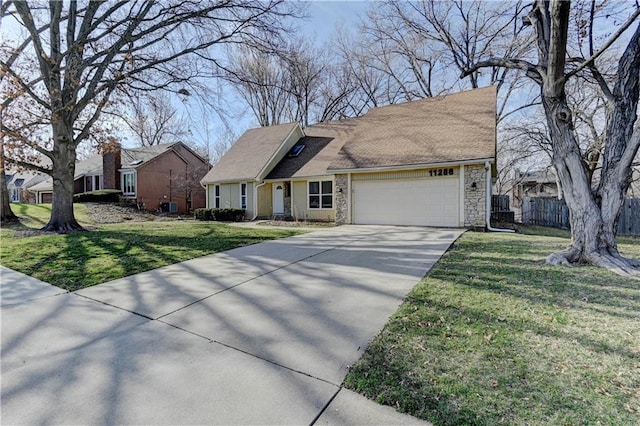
31;142;209;212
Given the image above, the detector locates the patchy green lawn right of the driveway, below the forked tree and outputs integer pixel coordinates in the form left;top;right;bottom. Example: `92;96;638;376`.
345;229;640;425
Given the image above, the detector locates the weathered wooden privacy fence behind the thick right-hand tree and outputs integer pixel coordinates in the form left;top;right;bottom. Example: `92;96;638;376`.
522;197;640;235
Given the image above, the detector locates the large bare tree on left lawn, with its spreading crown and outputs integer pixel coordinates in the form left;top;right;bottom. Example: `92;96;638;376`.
0;0;289;232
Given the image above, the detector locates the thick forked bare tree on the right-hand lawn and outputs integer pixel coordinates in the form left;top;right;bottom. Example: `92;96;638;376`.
463;0;640;275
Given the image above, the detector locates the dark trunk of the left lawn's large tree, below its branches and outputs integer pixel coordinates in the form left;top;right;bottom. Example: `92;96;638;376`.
42;119;83;234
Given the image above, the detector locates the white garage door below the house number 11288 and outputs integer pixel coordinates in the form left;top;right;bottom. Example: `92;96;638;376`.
352;177;460;227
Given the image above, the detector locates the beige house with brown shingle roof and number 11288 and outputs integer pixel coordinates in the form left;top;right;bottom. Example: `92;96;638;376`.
201;87;496;227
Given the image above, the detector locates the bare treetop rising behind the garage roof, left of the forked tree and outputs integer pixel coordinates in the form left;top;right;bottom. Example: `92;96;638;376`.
363;0;533;119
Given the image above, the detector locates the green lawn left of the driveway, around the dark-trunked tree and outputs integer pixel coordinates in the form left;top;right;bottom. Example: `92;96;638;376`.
0;205;297;291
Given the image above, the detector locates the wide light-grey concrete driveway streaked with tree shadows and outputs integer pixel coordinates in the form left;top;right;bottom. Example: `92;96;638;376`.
0;226;463;425
